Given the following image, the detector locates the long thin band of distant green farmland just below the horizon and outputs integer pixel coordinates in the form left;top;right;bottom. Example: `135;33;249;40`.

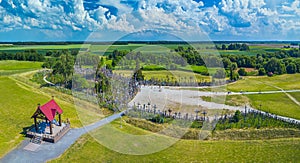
0;43;283;56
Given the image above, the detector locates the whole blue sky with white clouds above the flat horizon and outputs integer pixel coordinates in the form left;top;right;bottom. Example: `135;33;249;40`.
0;0;300;41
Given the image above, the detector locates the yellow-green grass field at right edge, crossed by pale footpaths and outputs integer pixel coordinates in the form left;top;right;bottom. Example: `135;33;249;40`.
223;74;300;119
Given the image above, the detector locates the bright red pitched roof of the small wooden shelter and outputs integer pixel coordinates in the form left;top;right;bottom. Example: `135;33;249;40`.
33;99;63;121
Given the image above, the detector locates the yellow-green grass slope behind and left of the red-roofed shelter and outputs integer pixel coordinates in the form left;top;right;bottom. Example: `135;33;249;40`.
0;77;103;157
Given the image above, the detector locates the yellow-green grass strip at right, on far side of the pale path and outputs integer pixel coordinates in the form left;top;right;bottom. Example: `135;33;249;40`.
227;74;300;92
